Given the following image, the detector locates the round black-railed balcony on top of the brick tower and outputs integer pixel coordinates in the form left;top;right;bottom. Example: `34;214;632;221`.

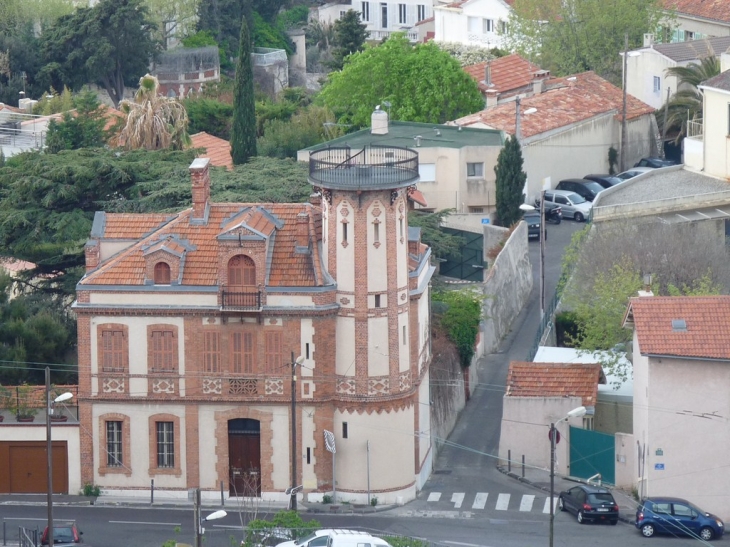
309;145;418;190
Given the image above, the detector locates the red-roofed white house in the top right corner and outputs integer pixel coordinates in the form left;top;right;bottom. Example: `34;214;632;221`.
662;0;730;42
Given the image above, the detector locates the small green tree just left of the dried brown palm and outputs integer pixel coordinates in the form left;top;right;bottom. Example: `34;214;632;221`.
46;90;107;153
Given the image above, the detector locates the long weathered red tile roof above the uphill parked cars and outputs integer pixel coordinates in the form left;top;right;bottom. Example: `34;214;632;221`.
456;71;654;137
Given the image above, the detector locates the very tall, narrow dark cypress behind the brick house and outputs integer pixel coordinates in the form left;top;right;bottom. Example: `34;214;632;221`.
231;19;256;165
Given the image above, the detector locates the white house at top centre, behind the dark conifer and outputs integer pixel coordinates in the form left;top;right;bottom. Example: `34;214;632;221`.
312;0;433;42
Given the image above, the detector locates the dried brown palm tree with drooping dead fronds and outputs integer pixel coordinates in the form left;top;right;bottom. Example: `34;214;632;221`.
118;74;190;150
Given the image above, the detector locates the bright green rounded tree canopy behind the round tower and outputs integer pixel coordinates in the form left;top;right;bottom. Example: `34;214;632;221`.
319;33;484;127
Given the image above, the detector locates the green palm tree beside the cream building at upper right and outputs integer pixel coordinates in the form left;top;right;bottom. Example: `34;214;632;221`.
657;51;720;143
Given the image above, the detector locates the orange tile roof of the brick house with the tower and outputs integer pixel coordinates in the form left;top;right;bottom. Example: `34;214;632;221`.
80;203;325;287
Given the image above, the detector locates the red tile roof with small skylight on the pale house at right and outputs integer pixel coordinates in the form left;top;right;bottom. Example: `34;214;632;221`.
624;296;730;359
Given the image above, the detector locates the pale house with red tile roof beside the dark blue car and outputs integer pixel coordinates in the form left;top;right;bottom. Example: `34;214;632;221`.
624;296;730;521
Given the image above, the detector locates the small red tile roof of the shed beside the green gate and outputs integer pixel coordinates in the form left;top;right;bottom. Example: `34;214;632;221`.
505;361;606;406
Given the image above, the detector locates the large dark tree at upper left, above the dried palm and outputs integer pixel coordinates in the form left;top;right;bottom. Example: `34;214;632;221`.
41;0;157;106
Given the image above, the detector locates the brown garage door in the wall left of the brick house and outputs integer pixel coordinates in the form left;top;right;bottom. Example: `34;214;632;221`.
0;441;68;494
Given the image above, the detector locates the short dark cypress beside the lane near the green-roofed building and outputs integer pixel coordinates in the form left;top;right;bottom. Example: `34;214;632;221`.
494;136;527;226
